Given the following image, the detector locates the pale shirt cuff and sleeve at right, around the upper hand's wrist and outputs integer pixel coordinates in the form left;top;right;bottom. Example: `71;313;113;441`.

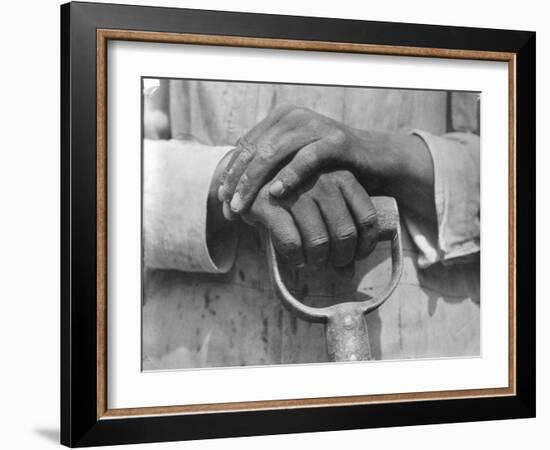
404;130;480;268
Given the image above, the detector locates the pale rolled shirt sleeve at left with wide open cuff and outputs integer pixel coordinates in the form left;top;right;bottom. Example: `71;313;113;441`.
142;139;237;273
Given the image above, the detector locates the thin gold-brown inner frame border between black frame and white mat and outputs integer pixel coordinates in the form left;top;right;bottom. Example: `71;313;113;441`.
96;29;516;420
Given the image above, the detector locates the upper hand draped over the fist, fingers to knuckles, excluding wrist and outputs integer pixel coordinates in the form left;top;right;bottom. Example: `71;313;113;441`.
218;106;380;218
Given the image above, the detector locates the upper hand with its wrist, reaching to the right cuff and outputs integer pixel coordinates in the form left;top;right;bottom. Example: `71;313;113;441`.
218;105;437;234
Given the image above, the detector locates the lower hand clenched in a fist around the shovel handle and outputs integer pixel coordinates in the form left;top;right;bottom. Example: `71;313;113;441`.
243;170;378;267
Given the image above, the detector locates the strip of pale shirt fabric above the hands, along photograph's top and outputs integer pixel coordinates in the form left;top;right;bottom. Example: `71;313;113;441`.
153;79;449;145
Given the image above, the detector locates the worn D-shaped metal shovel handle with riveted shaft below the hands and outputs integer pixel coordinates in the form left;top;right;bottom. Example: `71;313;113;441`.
266;197;403;361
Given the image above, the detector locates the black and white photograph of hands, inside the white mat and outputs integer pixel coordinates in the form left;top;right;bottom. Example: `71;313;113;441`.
140;76;485;371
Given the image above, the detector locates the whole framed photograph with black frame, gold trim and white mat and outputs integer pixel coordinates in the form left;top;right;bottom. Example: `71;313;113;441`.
61;3;536;447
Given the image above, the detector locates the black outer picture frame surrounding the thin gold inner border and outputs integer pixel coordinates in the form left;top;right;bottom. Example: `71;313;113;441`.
60;2;536;447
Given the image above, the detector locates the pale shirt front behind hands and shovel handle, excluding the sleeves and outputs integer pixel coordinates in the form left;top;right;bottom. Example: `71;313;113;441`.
142;80;480;370
